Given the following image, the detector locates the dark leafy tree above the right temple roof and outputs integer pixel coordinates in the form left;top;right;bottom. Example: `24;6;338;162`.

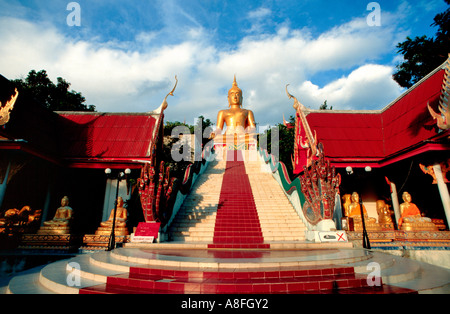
393;0;450;88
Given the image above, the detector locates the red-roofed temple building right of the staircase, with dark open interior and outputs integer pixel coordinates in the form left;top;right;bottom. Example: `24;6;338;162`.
289;61;450;243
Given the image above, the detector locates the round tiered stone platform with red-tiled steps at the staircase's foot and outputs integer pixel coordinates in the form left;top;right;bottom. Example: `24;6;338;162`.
7;243;450;294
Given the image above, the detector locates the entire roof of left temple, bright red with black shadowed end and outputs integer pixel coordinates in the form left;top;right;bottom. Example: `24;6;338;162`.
0;75;162;168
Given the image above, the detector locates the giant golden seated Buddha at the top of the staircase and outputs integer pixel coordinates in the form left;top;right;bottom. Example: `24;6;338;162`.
211;76;256;143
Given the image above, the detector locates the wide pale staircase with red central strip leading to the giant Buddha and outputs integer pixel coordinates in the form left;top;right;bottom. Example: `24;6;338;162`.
170;151;306;249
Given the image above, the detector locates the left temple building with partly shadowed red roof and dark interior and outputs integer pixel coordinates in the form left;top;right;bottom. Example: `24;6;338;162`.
0;76;164;248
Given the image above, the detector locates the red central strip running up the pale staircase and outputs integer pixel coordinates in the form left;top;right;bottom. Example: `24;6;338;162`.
208;150;270;249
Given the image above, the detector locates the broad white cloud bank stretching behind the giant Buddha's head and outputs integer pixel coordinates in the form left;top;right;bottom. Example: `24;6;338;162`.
0;8;406;124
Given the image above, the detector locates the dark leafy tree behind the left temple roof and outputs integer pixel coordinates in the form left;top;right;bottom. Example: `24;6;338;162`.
13;70;95;111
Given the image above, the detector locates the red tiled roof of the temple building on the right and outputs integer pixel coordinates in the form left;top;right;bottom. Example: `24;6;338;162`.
296;65;450;172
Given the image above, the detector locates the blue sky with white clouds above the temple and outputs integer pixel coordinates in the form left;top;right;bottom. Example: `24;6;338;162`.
0;0;447;125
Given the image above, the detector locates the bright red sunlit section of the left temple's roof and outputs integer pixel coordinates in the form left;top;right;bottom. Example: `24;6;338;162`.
59;112;159;168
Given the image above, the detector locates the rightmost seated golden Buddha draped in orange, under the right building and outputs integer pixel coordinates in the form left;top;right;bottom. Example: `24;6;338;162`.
398;192;438;231
